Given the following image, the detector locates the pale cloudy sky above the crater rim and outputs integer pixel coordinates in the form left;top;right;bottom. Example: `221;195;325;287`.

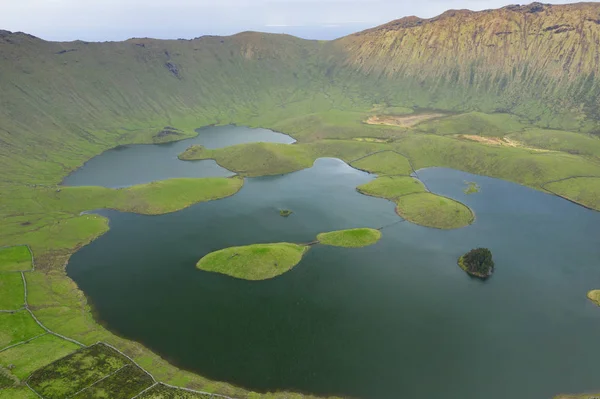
0;0;576;41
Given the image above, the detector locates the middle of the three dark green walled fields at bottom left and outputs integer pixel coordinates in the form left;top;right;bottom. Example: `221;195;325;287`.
72;365;154;399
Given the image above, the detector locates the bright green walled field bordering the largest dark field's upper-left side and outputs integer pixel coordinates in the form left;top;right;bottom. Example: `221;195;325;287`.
0;334;79;380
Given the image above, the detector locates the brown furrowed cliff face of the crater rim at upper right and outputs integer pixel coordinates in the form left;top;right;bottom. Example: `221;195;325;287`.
332;3;600;122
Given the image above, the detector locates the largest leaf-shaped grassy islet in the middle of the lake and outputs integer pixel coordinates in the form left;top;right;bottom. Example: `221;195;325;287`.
196;243;309;280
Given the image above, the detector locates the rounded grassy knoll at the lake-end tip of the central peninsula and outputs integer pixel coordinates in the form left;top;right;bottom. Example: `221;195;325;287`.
396;193;474;229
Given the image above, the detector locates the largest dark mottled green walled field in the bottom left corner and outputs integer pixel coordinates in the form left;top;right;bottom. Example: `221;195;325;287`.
29;344;133;399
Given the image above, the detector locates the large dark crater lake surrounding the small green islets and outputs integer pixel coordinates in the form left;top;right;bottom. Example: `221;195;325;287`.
67;128;600;399
